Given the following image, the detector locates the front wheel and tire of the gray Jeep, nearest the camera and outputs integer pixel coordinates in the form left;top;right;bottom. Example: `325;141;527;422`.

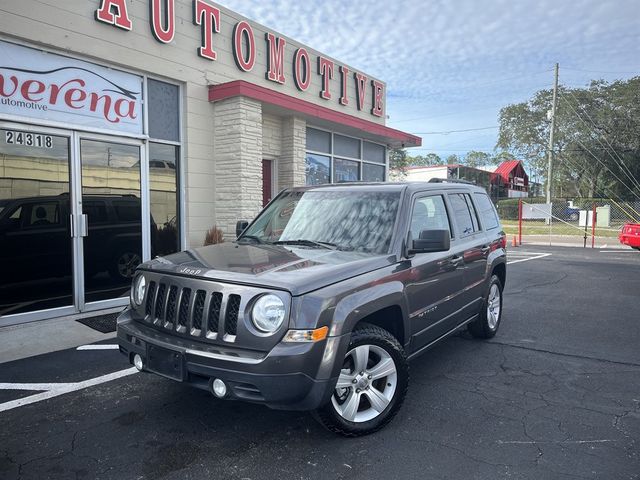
312;323;409;437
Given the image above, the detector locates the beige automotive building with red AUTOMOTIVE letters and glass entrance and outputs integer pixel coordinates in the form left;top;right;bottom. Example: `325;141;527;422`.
0;0;421;324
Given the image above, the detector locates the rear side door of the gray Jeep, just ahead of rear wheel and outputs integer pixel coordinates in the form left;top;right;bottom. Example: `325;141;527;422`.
447;191;490;321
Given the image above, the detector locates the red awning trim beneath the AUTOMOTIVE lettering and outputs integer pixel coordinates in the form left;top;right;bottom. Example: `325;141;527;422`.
209;80;422;147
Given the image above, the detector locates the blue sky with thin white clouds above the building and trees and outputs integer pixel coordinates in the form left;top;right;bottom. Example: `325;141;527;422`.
219;0;640;156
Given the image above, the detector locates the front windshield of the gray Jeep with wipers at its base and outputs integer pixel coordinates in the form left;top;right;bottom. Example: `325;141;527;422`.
238;190;400;253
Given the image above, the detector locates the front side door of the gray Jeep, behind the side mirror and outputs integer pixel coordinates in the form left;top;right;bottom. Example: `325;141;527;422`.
405;194;464;352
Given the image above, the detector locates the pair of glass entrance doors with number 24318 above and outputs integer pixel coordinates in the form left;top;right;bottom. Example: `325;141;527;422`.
0;123;145;325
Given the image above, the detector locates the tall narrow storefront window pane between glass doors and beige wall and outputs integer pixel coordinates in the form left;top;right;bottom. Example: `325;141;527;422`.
149;143;180;256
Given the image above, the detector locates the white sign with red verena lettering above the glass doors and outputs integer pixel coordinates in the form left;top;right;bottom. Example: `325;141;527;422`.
0;42;142;134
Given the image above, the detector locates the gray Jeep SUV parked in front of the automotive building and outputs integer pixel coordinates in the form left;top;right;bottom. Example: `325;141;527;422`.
118;181;506;436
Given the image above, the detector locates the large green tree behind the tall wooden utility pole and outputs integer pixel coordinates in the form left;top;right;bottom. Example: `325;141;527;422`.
496;77;640;200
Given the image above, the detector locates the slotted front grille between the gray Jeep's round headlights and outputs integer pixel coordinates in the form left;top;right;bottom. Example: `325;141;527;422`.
144;281;242;342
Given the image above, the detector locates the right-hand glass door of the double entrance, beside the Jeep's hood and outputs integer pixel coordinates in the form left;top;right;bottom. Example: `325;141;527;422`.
78;137;147;310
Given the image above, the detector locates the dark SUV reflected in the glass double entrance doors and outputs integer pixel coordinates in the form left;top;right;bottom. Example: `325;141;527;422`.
0;194;146;283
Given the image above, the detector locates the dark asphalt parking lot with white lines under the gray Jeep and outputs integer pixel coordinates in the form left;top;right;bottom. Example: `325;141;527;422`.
0;247;640;480
